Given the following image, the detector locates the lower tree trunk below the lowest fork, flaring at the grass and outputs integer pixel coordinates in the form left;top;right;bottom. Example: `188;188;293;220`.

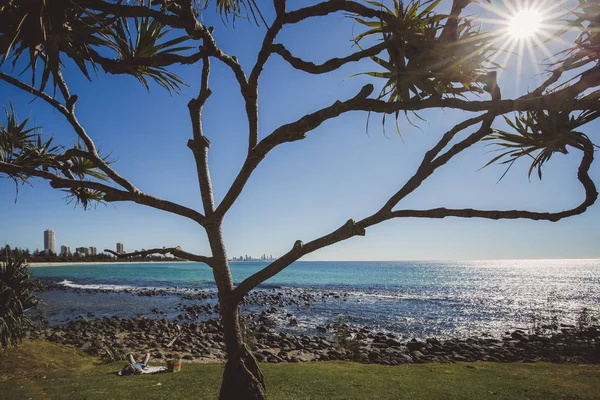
219;304;266;400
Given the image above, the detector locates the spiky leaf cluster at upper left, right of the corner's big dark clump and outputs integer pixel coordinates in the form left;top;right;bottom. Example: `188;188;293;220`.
109;17;193;92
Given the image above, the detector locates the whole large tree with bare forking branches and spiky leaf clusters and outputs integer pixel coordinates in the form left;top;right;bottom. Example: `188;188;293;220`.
0;0;600;399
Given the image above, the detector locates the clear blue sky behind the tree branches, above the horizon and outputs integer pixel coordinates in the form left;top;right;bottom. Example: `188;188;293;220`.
0;0;600;260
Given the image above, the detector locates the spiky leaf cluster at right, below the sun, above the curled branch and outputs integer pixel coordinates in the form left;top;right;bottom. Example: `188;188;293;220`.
483;110;600;179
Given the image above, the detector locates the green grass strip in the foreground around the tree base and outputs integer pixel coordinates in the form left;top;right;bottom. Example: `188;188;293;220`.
0;342;600;400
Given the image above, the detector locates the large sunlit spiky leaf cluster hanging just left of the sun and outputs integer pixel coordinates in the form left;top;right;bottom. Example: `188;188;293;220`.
353;0;499;134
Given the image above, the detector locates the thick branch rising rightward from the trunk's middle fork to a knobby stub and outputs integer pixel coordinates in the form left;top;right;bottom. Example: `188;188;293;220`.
216;84;373;217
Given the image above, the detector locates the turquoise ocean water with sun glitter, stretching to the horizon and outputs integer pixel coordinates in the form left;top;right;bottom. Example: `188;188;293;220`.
31;260;600;338
